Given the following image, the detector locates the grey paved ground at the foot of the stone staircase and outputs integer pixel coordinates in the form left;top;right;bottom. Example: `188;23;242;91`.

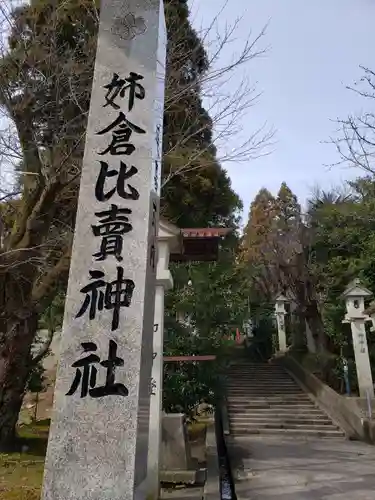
228;436;375;500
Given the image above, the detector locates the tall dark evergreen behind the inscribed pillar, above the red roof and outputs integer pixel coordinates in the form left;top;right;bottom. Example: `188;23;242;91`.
162;0;241;227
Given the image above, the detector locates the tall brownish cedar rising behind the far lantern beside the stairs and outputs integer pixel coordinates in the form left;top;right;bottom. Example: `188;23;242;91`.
242;183;327;349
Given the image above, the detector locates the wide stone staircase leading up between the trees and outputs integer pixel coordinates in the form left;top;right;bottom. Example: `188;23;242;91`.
227;360;345;438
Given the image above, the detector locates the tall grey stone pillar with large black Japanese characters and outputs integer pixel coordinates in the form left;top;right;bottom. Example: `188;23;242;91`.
42;0;167;500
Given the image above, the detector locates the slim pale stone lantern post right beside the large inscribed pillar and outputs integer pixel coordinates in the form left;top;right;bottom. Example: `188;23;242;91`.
147;221;180;499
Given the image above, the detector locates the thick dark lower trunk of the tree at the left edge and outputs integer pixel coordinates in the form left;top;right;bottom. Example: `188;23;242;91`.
0;313;38;450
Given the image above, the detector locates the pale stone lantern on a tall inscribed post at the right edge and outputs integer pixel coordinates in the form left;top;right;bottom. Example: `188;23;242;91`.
342;279;374;397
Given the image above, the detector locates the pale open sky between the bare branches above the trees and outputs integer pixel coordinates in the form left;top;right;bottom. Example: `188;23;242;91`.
191;0;375;220
